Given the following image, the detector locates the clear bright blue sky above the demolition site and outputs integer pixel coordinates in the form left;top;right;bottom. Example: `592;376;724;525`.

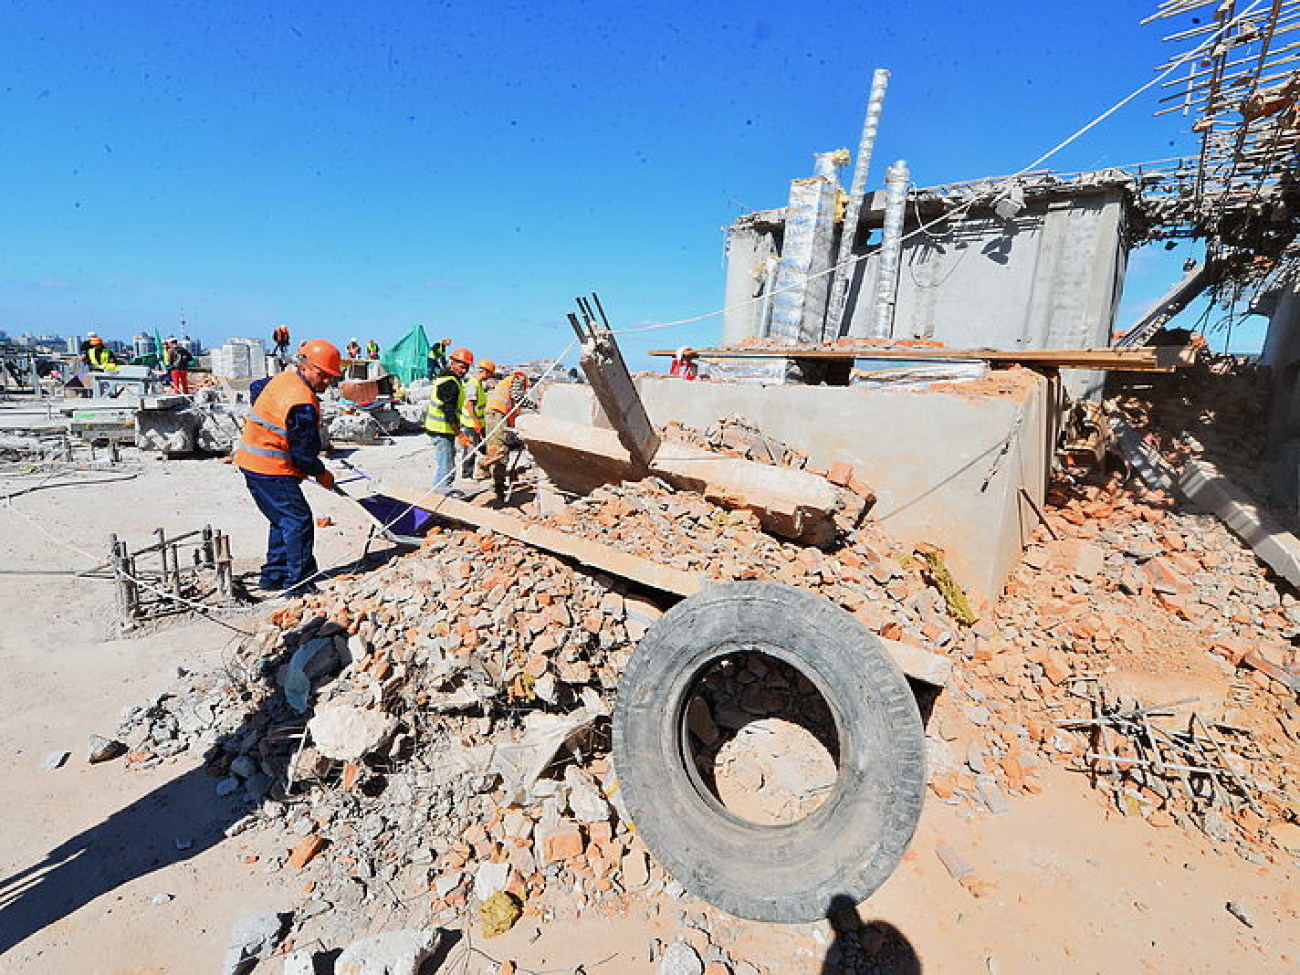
0;0;1248;360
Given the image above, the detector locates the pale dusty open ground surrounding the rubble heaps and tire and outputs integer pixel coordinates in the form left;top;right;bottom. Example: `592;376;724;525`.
0;423;1300;975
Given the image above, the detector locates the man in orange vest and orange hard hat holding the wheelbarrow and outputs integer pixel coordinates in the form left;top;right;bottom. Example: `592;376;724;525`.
234;338;343;595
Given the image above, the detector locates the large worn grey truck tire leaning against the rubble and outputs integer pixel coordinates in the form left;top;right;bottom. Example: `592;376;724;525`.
614;582;926;922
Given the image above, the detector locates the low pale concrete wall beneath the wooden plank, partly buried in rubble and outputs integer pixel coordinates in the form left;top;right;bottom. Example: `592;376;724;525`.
542;369;1057;601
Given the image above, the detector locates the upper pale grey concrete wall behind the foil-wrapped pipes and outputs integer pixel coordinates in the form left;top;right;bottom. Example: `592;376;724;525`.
723;170;1135;394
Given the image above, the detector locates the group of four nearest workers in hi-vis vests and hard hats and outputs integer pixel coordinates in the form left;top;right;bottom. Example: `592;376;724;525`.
234;335;528;595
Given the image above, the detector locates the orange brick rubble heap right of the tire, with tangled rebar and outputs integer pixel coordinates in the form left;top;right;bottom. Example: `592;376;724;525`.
931;475;1300;862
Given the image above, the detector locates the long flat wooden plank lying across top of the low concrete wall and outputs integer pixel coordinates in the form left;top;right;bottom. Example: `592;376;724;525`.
650;346;1182;372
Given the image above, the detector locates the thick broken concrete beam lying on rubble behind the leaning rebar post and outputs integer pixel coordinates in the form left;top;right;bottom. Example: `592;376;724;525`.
517;416;866;545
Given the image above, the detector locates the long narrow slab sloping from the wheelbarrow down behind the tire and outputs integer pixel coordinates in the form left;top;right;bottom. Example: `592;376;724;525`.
371;484;952;688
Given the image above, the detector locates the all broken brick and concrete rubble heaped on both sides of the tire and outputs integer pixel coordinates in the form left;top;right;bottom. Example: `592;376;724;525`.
111;441;1300;975
